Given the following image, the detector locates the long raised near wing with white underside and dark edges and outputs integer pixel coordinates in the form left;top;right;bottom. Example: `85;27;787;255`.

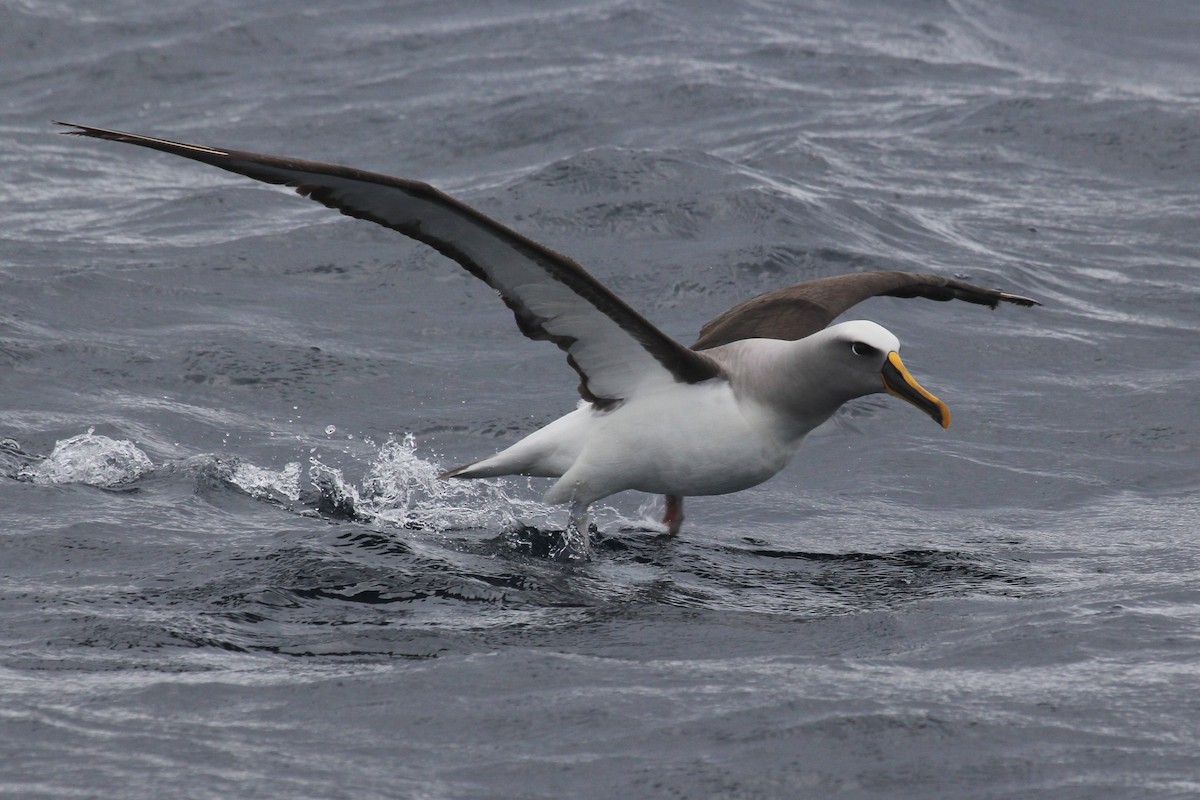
56;122;722;408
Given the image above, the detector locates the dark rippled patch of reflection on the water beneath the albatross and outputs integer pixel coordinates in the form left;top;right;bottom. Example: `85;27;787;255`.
56;523;1024;668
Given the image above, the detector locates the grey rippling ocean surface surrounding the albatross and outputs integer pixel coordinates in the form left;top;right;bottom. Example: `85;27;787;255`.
0;0;1200;800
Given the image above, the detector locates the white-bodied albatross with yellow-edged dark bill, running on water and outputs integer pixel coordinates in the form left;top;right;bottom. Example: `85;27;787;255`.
52;120;1040;561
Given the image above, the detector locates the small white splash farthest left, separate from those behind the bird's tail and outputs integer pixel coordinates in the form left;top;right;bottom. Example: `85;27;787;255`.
17;428;155;488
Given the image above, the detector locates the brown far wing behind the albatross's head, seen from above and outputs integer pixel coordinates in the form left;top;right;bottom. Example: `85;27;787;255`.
691;271;1042;350
